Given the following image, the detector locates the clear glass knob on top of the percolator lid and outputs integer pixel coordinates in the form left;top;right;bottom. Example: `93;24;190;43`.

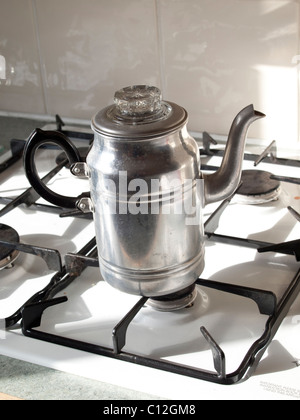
114;85;162;117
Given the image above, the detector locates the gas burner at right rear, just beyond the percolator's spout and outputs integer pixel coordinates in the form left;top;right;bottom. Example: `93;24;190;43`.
235;169;280;204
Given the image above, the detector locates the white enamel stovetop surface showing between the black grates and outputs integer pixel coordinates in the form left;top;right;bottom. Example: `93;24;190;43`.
0;139;300;400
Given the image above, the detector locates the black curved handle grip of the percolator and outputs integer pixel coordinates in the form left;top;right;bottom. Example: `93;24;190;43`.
23;128;81;208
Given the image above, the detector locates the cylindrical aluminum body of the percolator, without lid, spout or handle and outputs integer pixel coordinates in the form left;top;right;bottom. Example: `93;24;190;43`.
87;123;204;297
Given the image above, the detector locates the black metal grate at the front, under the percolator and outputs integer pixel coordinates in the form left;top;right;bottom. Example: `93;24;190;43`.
21;243;300;385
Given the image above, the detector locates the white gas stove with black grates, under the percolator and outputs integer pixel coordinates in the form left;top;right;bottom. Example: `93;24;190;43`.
0;121;300;400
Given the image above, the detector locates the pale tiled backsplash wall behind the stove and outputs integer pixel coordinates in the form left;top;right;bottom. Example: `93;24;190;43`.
0;0;300;147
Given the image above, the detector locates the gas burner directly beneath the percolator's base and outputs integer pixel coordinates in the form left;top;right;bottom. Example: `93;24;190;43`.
147;284;197;312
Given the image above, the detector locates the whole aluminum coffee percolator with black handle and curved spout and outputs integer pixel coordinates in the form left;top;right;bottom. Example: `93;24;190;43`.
24;85;264;310
